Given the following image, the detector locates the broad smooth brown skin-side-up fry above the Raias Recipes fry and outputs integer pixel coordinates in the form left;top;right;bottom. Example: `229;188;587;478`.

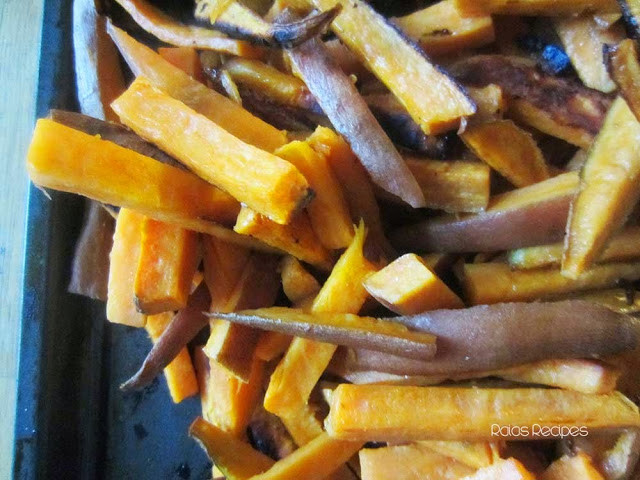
336;300;638;378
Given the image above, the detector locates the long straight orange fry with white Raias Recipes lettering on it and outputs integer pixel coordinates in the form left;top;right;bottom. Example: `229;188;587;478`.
325;384;640;442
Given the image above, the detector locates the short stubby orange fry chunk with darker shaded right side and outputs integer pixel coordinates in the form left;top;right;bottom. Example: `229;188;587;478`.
134;218;200;315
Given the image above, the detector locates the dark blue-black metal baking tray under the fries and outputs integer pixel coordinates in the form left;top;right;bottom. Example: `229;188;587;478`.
13;0;211;479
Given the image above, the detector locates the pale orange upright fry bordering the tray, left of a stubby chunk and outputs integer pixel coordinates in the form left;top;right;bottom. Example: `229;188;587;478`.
107;208;146;327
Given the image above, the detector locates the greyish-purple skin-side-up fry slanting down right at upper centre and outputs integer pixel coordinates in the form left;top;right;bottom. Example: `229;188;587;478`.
288;33;424;207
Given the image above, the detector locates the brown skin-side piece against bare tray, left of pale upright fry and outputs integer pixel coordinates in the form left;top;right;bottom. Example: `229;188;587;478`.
68;201;115;301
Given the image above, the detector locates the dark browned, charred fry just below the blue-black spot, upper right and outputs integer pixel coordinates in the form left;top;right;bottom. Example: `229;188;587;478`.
451;55;611;148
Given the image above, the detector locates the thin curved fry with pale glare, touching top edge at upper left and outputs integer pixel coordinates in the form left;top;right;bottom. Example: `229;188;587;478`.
112;0;263;58
